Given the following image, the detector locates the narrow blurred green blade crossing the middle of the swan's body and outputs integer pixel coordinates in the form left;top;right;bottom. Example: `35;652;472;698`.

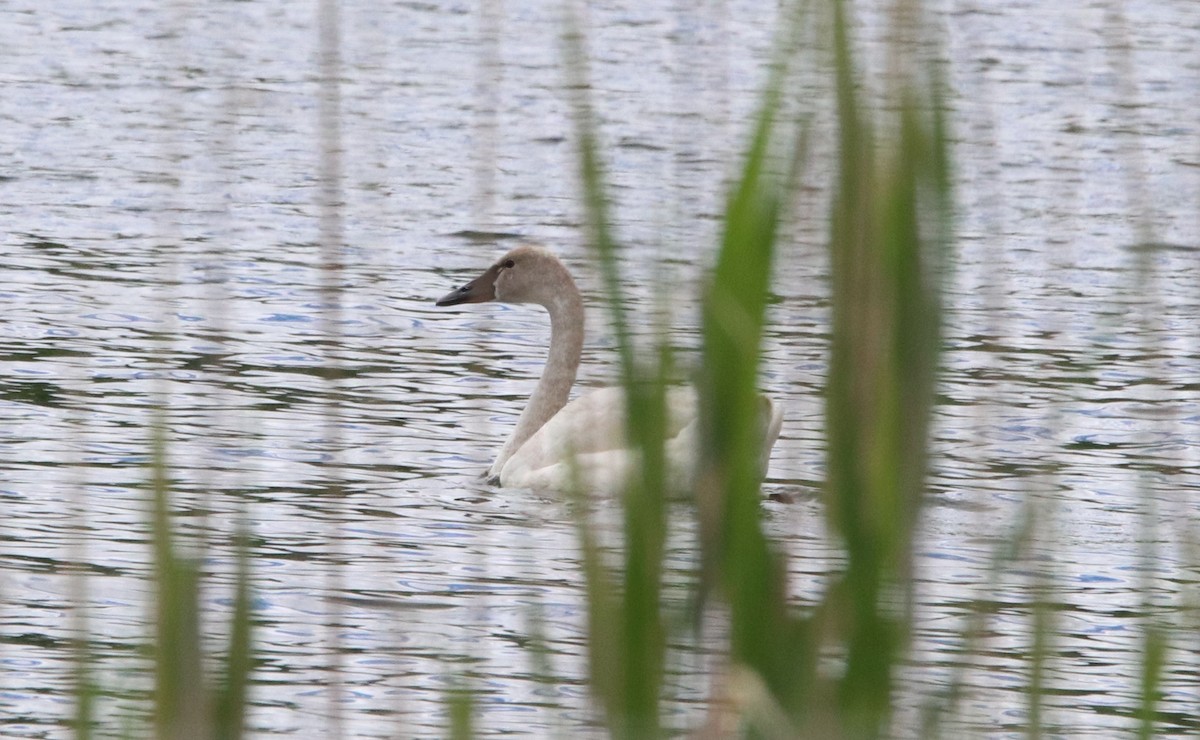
564;4;670;738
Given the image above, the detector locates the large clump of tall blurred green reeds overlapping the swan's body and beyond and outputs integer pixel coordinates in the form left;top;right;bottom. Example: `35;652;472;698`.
568;2;950;738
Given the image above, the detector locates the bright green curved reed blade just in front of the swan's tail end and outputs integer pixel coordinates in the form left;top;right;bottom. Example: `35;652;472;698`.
696;0;816;719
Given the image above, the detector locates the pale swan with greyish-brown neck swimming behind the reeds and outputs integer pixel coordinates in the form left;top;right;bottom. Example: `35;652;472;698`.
437;246;782;492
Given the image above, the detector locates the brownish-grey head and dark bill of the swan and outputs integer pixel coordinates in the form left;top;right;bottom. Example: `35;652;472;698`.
437;246;576;307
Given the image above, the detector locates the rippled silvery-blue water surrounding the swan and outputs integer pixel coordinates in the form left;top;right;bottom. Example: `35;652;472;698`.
0;0;1200;738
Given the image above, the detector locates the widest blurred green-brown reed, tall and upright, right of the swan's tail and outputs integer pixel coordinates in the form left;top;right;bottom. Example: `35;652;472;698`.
826;1;949;738
